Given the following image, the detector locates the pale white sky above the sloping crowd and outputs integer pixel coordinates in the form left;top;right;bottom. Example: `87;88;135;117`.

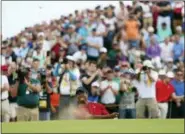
2;1;131;39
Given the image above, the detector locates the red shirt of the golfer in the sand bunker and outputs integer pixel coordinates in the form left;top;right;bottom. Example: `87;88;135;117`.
82;102;109;115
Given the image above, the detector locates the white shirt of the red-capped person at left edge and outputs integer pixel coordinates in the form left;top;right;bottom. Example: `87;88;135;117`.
0;75;9;100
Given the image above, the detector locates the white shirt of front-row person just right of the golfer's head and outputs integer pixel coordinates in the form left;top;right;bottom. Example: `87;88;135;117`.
100;80;119;104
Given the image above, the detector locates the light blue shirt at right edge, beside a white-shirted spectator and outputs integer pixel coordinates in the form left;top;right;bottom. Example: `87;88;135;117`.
173;43;184;60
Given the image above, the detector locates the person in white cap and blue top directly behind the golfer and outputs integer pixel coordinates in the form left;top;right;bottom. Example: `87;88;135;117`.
88;81;100;103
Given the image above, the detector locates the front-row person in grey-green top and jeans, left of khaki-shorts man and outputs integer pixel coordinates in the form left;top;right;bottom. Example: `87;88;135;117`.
119;70;136;119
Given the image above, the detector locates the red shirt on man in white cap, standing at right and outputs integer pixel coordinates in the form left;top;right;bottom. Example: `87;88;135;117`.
156;80;175;102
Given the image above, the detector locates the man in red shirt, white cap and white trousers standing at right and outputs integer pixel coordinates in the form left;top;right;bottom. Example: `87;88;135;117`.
156;72;180;119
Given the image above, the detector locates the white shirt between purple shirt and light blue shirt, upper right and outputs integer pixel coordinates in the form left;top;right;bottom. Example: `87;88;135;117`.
159;42;174;61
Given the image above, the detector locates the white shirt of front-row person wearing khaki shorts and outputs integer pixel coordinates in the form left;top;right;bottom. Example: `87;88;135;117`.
133;71;158;99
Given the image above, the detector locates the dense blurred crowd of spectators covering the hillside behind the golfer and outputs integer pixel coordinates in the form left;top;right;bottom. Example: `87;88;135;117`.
0;1;185;122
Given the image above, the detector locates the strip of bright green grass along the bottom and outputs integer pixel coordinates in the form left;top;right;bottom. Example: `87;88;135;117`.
2;119;184;133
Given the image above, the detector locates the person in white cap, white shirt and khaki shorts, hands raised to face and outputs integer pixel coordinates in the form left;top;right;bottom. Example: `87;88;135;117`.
134;60;158;118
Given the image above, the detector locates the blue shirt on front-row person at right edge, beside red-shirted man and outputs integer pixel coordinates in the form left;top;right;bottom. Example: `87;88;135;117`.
171;80;184;96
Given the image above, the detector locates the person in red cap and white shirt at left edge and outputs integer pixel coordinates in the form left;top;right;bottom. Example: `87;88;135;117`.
1;65;10;122
